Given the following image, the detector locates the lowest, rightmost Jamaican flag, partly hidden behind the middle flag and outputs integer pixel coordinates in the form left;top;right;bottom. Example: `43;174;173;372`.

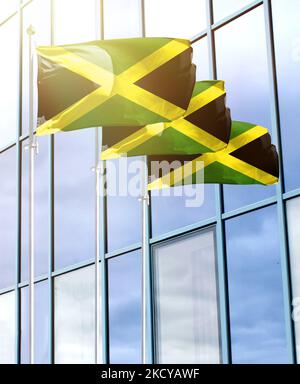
149;121;279;190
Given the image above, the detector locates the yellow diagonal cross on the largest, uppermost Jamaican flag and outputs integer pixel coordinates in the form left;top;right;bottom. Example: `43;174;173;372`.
37;40;190;135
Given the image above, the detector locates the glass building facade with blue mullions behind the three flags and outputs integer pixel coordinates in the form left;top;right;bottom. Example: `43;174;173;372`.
0;0;300;364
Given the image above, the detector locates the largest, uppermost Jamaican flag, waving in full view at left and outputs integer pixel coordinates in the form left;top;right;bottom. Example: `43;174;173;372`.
37;38;195;135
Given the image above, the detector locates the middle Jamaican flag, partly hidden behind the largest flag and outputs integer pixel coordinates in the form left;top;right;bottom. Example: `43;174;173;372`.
101;81;231;160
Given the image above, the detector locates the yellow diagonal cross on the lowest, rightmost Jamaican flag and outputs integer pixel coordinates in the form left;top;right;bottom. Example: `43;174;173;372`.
148;126;278;190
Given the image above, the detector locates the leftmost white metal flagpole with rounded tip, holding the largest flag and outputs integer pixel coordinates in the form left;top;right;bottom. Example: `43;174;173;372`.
27;26;37;364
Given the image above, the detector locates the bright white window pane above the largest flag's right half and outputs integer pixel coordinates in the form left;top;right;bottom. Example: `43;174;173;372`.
145;0;206;39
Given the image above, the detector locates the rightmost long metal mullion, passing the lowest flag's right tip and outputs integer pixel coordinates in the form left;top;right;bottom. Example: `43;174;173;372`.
263;0;297;363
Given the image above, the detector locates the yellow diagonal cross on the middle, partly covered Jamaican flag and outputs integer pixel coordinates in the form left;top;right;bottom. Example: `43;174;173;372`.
101;81;227;160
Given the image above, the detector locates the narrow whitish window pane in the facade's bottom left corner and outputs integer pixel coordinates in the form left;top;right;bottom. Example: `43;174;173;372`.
0;292;16;364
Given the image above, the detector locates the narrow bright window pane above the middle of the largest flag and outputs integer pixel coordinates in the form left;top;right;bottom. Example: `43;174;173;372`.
104;0;141;39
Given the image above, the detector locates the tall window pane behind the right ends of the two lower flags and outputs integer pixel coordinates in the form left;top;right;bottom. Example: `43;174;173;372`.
216;7;275;211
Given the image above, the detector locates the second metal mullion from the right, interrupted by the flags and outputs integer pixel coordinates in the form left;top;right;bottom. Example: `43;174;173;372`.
206;0;231;364
